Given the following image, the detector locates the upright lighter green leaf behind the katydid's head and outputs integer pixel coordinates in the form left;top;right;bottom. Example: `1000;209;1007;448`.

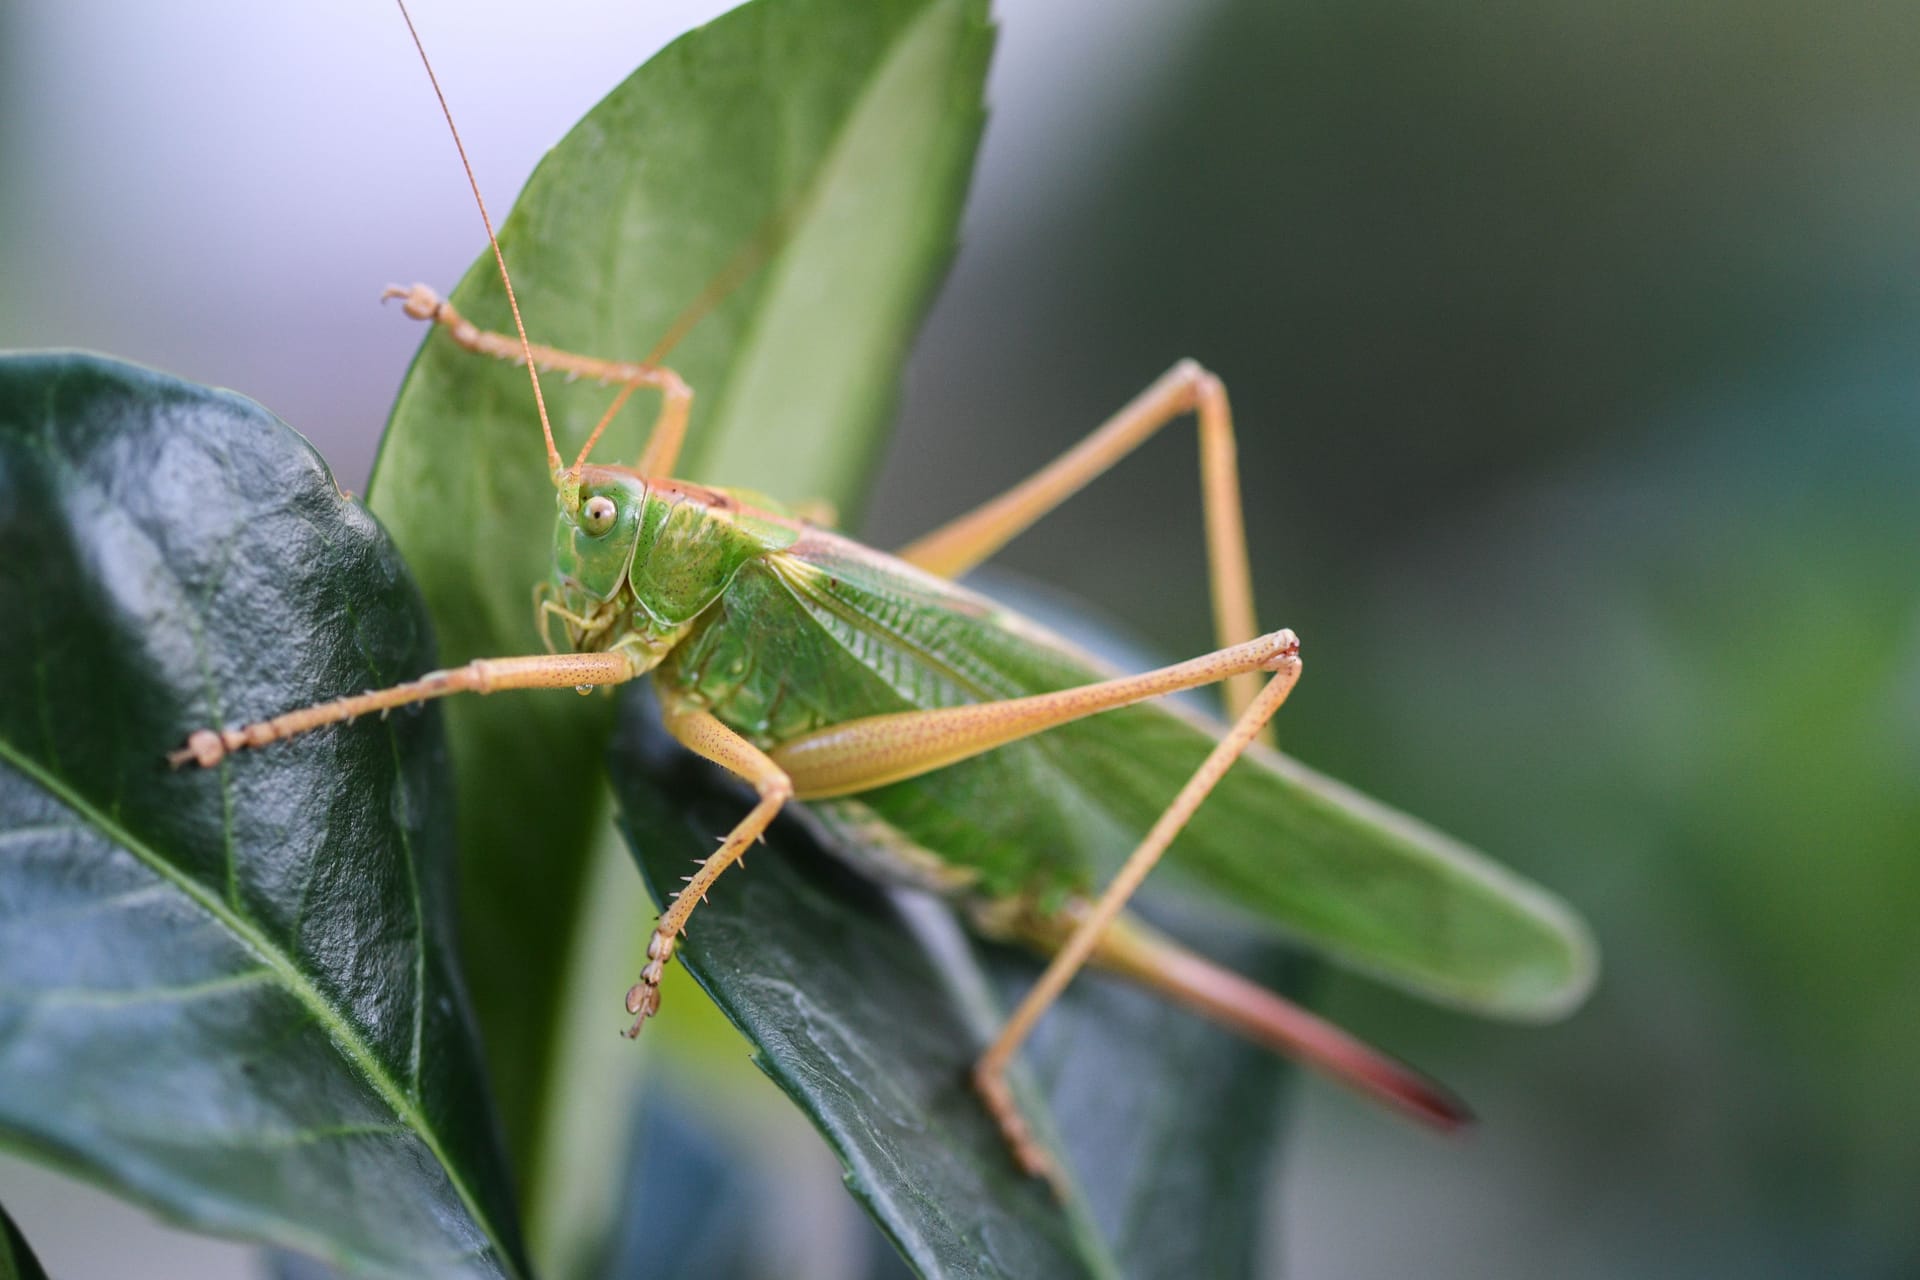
371;0;991;1212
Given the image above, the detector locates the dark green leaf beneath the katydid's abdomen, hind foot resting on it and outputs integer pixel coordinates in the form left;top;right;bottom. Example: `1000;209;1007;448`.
614;697;1288;1280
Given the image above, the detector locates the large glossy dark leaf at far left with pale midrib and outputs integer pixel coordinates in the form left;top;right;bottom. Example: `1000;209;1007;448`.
0;357;522;1276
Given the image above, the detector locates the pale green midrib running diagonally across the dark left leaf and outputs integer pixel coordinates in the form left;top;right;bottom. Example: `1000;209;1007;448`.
0;737;520;1274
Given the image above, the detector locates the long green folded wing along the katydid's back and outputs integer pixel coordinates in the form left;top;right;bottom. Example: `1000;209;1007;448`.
683;533;1596;1019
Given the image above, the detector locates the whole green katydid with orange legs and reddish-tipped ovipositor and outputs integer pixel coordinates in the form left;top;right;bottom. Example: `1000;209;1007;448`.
175;0;1592;1173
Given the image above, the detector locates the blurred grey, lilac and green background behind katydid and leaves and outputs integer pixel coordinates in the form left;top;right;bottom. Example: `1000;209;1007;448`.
0;0;1920;1278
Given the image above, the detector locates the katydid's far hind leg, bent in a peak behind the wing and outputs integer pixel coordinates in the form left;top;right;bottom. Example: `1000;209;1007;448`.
897;361;1267;737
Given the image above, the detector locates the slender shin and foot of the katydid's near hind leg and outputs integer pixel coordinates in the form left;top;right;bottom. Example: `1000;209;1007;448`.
973;651;1300;1176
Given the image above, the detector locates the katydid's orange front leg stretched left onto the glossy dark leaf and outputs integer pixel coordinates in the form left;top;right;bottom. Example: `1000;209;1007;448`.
167;652;636;768
